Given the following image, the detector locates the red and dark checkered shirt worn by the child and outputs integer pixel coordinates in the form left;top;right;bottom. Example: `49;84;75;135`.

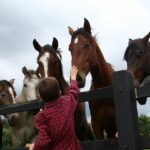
34;80;80;150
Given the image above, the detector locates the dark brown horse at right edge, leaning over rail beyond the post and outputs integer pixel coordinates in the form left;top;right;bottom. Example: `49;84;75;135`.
124;33;150;104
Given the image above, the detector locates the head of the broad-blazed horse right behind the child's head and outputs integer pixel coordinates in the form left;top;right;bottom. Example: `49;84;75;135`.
33;38;62;78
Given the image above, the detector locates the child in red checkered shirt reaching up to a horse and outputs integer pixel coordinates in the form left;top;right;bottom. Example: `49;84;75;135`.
27;66;80;150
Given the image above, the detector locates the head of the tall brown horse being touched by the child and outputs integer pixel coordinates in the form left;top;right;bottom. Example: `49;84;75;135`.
68;19;100;88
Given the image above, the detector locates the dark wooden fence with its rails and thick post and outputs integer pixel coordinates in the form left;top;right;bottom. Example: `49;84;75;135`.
0;70;150;150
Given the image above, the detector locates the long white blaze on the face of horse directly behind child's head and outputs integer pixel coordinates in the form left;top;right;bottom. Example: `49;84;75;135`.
39;52;50;77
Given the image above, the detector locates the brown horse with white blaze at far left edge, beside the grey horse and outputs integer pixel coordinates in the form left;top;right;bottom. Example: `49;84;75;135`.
0;79;16;148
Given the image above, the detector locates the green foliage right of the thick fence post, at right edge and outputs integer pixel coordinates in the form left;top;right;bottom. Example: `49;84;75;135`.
139;115;150;136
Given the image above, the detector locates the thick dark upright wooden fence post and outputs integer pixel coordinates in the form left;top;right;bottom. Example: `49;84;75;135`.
113;71;141;150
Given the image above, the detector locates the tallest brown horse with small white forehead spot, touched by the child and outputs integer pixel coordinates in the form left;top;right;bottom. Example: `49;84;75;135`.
69;19;117;139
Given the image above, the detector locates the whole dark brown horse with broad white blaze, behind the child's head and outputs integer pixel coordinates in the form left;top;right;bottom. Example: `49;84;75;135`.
33;38;94;141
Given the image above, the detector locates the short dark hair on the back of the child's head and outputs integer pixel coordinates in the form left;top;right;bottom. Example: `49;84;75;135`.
38;77;60;102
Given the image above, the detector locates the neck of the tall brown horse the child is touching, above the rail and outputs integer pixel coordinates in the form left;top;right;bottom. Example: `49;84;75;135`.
91;45;113;88
